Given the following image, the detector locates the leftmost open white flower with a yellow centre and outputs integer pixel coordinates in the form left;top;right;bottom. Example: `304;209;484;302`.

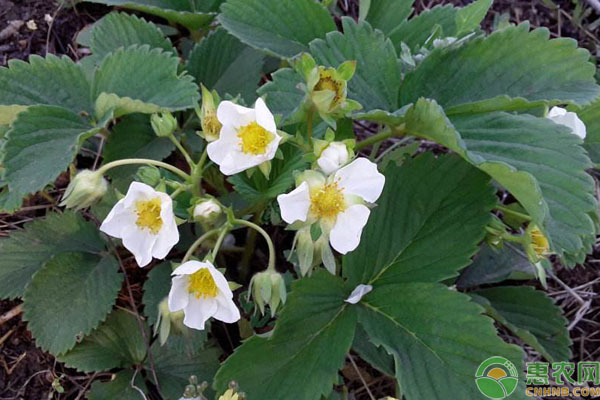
100;182;179;267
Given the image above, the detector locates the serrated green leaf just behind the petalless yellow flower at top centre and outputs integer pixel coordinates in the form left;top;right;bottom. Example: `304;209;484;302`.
310;17;402;111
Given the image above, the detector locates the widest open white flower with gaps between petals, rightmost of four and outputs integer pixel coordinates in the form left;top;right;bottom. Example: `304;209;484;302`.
277;158;385;254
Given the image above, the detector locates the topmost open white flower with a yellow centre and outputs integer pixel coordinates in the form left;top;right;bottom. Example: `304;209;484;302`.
207;98;281;175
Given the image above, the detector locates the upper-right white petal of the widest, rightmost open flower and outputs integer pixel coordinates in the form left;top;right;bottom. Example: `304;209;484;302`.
334;158;385;203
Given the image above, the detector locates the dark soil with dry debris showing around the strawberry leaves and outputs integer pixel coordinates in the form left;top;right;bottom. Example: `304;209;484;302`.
0;0;600;400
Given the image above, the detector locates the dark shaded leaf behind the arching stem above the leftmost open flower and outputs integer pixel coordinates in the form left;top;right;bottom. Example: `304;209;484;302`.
103;114;175;191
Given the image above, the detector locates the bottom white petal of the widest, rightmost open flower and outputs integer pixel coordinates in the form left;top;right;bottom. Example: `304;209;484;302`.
329;204;371;254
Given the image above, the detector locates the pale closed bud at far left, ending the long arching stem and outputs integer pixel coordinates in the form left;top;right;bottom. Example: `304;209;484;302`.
60;169;108;210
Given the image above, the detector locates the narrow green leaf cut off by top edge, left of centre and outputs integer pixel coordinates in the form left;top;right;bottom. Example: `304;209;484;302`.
85;0;223;31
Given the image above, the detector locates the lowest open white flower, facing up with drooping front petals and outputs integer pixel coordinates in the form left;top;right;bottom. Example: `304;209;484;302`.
169;261;240;329
